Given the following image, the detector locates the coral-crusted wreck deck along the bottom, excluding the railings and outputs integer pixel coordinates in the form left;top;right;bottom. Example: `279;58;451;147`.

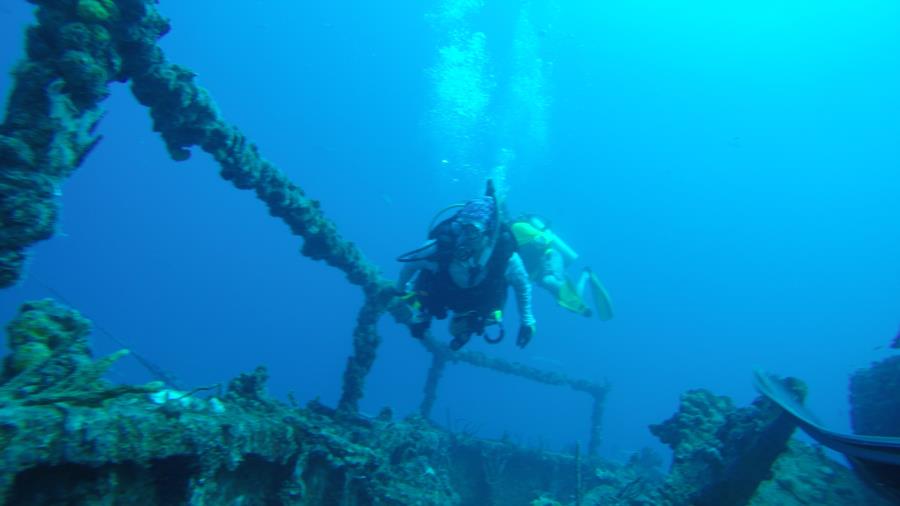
0;300;885;506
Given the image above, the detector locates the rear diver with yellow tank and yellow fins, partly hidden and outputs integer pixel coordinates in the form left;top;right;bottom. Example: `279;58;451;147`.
512;214;613;321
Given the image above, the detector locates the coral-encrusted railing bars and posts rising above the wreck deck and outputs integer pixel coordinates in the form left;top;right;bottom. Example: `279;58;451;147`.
0;0;608;453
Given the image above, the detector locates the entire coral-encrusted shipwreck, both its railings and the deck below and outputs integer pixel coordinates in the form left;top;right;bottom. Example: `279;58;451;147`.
0;0;882;505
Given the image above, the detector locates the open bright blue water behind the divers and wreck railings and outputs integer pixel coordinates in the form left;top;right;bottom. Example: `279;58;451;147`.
0;0;900;458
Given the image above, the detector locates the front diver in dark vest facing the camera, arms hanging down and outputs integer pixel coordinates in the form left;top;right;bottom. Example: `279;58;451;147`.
397;180;535;350
